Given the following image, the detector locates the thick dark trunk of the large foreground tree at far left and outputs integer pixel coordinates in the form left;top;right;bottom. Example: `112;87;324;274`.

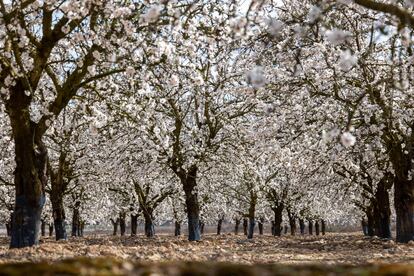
6;101;48;248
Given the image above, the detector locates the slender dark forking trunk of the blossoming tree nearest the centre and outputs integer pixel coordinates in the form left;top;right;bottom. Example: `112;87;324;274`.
180;166;201;241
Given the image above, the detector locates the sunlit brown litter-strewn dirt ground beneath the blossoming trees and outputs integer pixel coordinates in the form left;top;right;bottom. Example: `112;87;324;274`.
0;233;414;265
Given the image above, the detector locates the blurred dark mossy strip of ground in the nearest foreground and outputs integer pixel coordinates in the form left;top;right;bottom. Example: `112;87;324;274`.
0;258;414;276
